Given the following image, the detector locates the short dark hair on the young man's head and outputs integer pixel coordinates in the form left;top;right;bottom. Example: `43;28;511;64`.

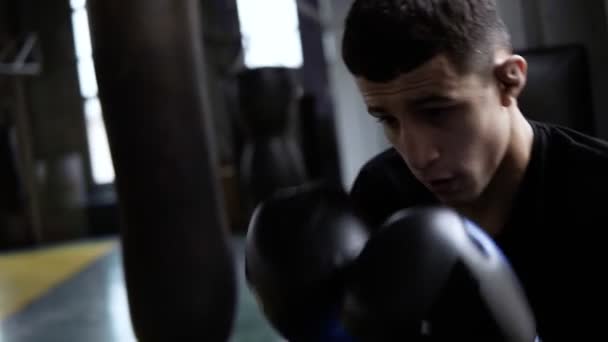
342;0;511;82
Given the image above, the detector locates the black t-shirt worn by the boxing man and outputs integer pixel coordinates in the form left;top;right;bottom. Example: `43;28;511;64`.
351;121;608;342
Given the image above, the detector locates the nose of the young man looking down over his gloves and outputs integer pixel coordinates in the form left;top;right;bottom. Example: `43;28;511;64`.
399;127;440;172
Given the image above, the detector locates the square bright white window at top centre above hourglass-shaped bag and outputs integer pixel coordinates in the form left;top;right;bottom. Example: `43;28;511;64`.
237;0;303;68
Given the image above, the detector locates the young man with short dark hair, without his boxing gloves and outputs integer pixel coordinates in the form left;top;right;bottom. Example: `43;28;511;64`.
343;0;608;341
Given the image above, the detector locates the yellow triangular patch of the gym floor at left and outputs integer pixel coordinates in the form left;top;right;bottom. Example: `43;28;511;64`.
0;240;116;321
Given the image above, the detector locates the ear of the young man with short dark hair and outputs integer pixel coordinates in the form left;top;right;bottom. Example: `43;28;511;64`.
494;55;528;107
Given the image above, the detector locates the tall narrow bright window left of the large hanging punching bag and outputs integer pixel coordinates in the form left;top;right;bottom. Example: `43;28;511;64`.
70;0;114;184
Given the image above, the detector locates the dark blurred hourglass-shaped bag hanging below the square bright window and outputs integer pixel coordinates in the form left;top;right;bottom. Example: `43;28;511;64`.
237;67;307;211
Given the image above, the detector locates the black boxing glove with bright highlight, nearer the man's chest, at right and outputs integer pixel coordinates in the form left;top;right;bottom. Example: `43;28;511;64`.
343;207;537;342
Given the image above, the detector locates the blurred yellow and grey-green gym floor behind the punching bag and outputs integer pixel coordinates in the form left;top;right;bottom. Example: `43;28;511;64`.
0;237;281;342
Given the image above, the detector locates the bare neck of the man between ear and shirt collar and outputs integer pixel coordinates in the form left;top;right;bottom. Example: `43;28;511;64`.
456;107;534;236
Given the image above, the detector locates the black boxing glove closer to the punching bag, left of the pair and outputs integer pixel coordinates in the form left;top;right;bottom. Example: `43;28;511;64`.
245;183;368;342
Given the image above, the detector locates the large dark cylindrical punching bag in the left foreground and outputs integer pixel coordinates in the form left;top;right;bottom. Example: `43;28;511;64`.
89;0;236;342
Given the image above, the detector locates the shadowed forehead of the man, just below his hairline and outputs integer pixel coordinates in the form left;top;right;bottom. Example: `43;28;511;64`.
356;56;458;97
